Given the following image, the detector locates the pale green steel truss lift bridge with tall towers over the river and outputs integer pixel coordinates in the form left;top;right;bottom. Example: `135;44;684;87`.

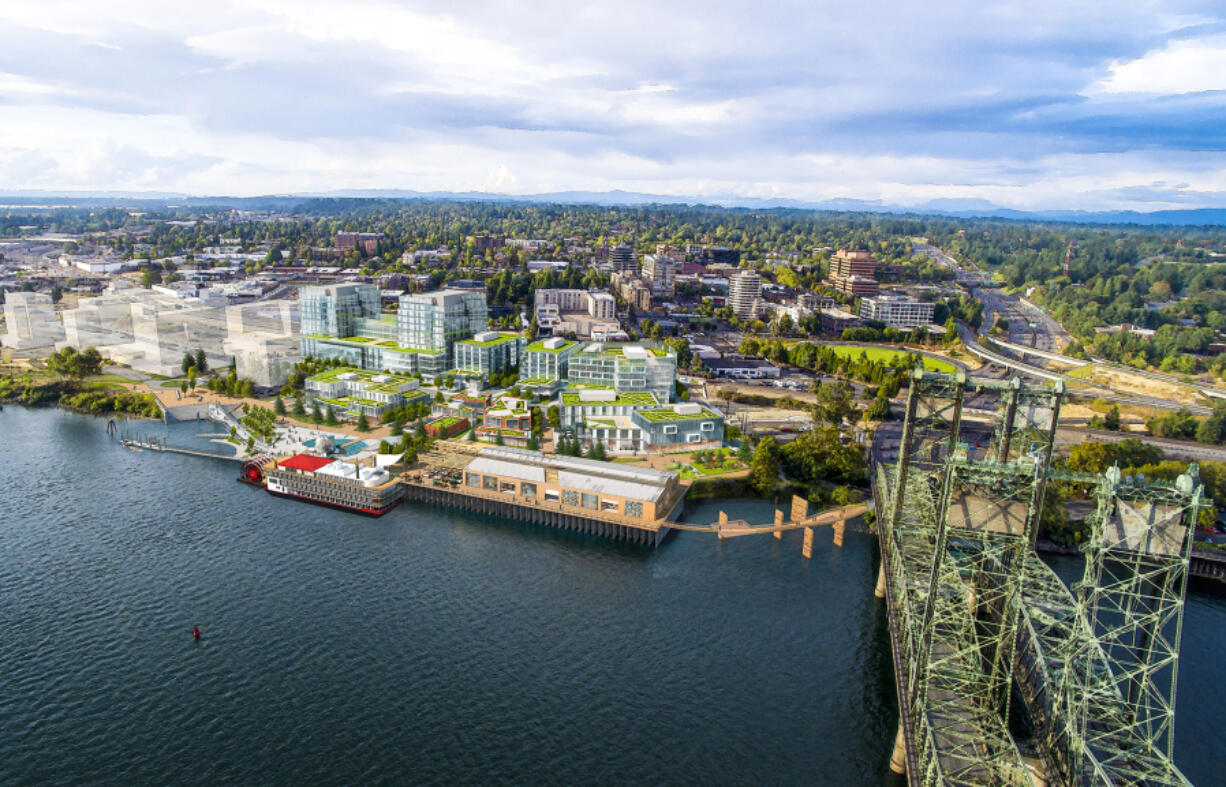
873;370;1208;786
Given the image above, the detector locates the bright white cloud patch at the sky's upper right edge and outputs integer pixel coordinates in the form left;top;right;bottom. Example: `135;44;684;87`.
1086;37;1226;96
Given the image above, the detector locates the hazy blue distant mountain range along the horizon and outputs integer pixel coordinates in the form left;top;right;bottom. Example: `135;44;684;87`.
0;189;1226;227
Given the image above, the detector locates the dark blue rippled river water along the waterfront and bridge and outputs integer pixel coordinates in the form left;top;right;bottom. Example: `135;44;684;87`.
0;407;1226;785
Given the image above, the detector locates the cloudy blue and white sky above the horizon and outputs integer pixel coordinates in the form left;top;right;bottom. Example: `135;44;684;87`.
0;0;1226;211
